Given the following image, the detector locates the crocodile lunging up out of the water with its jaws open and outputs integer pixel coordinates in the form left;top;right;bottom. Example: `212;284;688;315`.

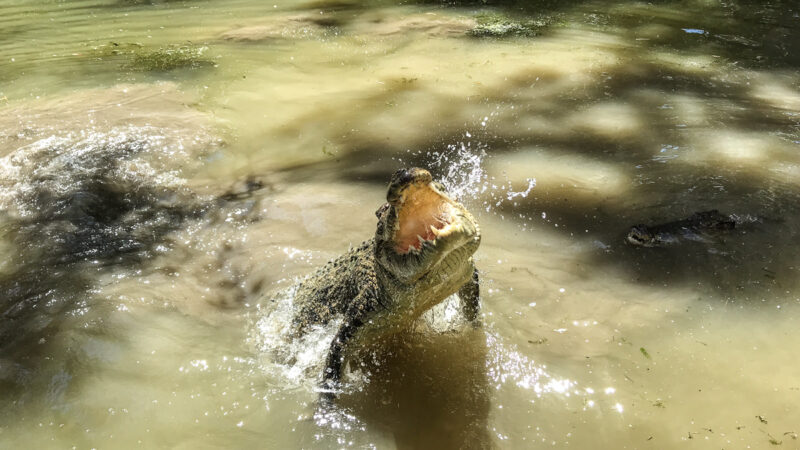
293;168;481;391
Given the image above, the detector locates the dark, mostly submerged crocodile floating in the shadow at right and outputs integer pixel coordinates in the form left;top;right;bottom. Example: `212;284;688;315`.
626;209;736;247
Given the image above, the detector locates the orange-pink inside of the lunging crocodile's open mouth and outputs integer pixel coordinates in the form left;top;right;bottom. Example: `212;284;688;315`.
394;183;456;253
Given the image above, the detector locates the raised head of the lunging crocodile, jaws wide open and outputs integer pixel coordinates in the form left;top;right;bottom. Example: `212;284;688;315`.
375;168;481;282
